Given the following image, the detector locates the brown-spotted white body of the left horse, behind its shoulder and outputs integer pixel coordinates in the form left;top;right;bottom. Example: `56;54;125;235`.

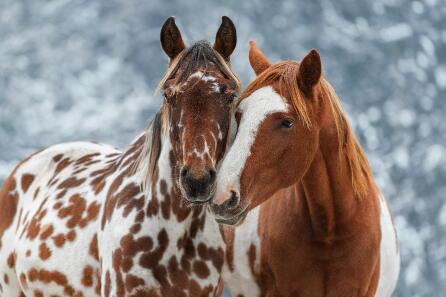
0;142;116;297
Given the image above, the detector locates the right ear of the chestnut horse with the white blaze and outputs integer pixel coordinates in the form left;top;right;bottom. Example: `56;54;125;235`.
297;49;322;95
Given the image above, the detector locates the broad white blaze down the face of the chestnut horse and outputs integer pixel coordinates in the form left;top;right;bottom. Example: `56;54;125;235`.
214;86;289;204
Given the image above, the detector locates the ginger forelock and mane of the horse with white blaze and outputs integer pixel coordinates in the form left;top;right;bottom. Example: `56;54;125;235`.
239;61;374;197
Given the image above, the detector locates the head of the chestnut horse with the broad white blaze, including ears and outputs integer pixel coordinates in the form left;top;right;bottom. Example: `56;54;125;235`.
211;42;372;224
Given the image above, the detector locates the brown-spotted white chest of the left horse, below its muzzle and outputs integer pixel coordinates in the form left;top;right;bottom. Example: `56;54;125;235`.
99;180;223;296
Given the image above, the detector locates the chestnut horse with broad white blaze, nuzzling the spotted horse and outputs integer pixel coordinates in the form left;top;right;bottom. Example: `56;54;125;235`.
212;43;400;297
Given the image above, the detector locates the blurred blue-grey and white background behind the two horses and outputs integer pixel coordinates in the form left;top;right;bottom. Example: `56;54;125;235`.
0;0;446;297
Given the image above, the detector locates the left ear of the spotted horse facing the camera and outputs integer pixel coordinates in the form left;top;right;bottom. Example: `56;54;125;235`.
160;16;186;60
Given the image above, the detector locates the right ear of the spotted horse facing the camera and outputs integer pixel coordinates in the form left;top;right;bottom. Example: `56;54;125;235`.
214;16;237;61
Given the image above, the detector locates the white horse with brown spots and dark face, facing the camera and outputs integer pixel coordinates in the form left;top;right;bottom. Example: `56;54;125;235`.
0;17;239;297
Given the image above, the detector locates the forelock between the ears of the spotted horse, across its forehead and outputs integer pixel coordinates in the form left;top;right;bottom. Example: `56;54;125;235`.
156;40;241;92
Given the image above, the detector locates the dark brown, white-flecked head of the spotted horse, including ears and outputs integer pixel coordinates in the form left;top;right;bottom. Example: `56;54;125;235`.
159;17;240;203
